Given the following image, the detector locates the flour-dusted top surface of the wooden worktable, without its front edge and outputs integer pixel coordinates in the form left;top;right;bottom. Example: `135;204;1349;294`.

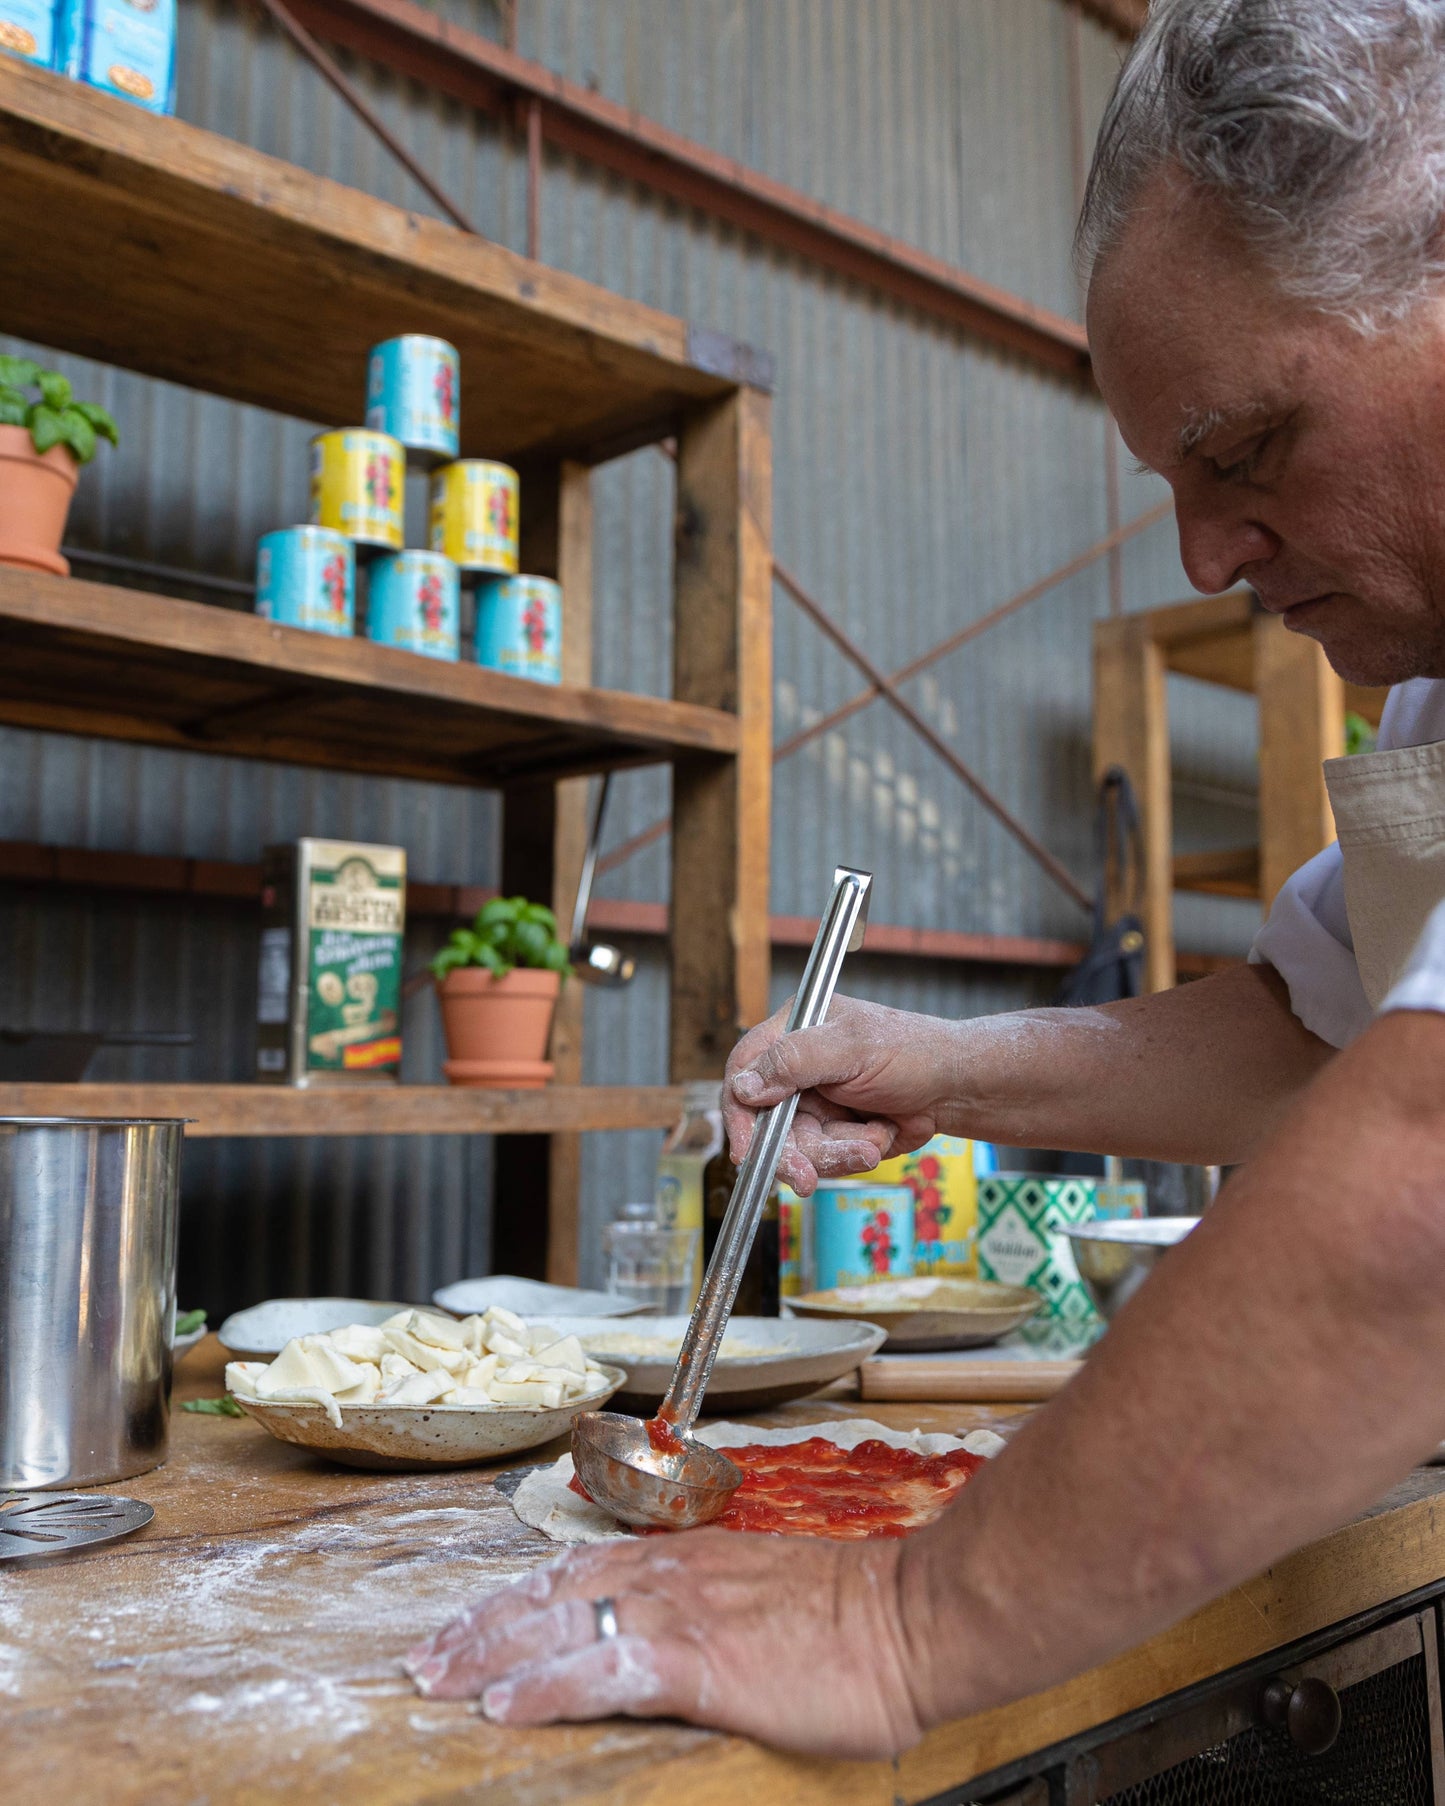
0;1338;1025;1806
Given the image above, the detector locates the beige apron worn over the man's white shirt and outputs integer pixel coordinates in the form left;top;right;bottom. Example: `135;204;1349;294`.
1324;740;1445;1010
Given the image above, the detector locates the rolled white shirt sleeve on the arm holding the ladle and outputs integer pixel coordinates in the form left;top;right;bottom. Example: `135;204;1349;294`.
1250;843;1372;1047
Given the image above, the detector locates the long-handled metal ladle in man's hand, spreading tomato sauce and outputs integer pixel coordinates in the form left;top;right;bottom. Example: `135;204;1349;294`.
573;865;872;1530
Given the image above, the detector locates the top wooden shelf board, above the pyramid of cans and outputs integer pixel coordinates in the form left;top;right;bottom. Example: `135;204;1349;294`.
0;58;751;461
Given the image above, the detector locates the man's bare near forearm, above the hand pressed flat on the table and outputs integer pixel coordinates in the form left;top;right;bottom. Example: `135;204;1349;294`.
900;1013;1445;1723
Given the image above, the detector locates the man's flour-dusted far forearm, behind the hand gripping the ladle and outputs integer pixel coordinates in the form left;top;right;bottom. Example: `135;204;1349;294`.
939;966;1333;1165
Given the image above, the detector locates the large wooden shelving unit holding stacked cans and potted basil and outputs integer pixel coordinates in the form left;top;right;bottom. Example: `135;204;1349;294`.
0;58;771;1280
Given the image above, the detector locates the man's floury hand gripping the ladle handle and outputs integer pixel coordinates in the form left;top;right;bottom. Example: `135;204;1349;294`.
723;997;957;1197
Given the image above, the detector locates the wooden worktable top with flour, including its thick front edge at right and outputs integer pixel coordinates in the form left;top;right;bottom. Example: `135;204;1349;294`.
0;1338;1445;1806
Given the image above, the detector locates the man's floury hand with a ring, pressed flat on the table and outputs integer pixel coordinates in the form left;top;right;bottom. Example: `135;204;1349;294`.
406;1530;923;1757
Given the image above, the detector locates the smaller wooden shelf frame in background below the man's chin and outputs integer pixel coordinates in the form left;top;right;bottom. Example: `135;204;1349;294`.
1093;589;1385;991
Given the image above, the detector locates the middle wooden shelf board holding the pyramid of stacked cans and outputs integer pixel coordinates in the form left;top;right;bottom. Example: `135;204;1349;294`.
0;567;739;784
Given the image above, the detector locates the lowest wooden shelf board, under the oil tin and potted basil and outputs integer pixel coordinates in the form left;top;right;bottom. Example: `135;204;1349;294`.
0;1084;685;1138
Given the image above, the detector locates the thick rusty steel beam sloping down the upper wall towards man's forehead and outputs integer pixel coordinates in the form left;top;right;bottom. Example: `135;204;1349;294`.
261;0;1089;377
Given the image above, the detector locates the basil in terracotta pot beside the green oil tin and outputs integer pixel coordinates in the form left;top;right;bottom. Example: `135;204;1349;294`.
432;898;571;1087
